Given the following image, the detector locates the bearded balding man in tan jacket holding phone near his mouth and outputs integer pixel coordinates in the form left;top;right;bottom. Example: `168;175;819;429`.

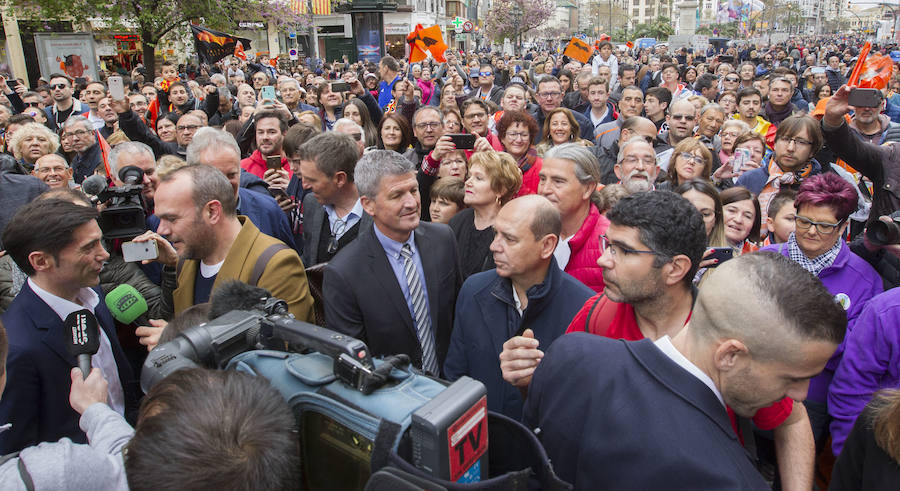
136;164;315;345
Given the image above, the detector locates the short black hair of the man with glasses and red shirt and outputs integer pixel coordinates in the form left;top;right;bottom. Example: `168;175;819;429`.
606;191;707;286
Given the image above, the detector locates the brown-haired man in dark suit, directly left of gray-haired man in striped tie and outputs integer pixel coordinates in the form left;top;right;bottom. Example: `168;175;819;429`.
297;131;372;266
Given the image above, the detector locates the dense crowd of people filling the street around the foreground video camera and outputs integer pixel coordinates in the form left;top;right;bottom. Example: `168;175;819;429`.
0;34;900;490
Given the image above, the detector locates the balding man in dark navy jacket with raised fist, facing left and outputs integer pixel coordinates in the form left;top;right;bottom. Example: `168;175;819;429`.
444;195;594;419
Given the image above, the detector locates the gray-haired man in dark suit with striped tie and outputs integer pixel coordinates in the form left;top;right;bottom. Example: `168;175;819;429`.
323;150;461;375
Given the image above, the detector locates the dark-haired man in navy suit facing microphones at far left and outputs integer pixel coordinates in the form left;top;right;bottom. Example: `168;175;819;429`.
0;199;138;454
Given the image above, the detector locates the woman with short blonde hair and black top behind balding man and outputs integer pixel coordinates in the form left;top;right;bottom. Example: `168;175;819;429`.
450;151;522;279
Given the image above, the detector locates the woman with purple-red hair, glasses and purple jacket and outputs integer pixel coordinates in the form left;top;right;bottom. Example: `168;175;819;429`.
762;172;883;450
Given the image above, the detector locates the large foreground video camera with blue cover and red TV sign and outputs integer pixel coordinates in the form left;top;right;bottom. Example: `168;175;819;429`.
141;290;496;490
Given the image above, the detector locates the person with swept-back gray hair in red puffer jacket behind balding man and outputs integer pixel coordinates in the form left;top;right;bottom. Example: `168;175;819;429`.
538;143;609;292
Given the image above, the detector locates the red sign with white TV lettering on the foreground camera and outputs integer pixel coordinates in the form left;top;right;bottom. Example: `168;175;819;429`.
447;396;488;481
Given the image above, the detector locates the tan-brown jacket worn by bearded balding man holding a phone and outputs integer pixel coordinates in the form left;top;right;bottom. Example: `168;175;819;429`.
173;215;315;323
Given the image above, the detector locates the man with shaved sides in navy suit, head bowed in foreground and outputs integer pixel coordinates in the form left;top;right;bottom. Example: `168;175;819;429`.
523;254;847;490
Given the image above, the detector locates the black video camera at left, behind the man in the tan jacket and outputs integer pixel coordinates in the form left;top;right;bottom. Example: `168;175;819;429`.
81;165;147;240
